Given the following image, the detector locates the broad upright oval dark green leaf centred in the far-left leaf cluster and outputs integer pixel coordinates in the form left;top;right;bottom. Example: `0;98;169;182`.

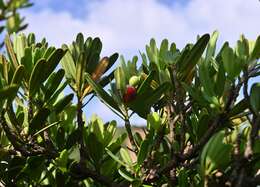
29;59;46;97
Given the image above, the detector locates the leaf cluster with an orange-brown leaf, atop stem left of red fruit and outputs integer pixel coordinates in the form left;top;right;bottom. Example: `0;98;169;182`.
62;33;118;101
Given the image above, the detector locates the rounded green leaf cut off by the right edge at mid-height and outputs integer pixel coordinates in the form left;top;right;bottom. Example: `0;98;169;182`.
250;83;260;114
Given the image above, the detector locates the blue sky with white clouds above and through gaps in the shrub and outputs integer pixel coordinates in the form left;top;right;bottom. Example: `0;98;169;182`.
23;0;260;124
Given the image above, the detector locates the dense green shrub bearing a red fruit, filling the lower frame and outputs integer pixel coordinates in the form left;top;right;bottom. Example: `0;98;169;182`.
0;32;260;187
